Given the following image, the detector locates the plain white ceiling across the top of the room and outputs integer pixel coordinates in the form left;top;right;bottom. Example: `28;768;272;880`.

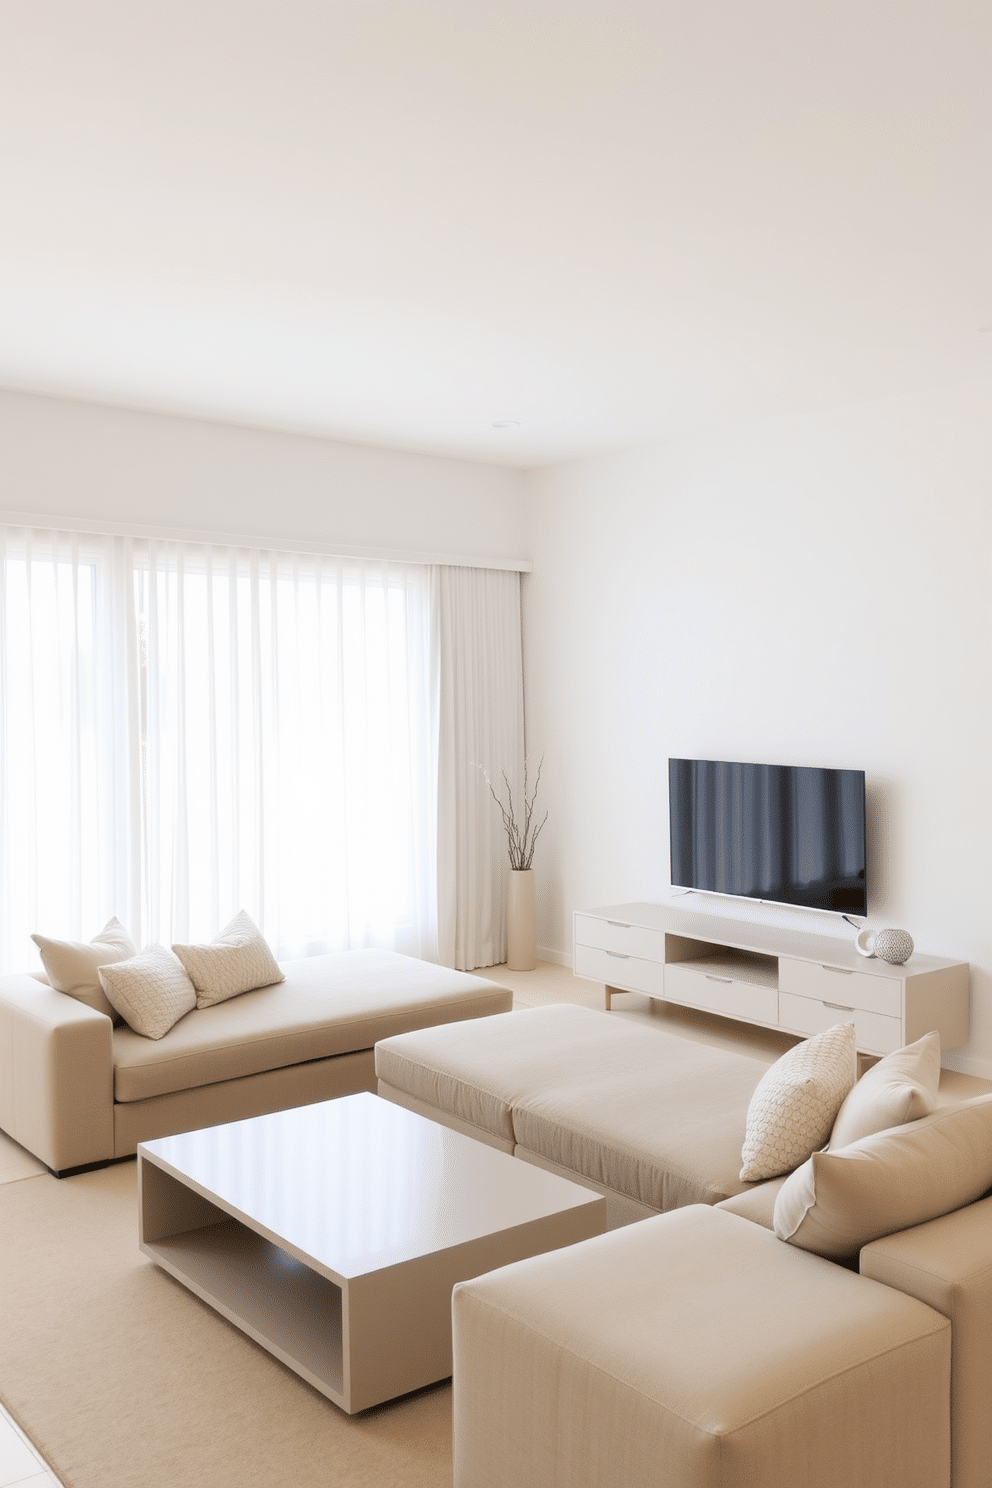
0;0;992;466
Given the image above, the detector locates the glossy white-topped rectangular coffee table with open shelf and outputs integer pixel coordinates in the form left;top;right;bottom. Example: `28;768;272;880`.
138;1095;605;1412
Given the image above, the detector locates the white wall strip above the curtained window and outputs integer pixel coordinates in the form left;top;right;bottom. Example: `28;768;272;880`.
0;393;524;562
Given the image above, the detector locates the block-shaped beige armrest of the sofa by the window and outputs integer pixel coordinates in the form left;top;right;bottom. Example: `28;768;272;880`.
0;975;113;1173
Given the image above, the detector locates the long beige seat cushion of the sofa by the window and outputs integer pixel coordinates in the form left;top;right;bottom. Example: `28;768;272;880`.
113;951;512;1101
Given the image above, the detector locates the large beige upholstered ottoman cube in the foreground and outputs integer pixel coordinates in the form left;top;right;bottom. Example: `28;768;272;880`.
452;1205;950;1488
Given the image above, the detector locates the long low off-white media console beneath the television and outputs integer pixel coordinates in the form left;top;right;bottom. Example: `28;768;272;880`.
574;905;970;1054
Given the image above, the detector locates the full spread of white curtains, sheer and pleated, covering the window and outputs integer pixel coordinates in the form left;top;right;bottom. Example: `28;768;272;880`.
0;527;524;970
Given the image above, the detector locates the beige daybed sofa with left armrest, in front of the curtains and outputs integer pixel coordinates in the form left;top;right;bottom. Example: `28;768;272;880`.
0;951;513;1176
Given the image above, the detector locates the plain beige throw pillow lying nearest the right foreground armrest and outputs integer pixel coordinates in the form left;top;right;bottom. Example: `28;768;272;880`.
773;1095;992;1260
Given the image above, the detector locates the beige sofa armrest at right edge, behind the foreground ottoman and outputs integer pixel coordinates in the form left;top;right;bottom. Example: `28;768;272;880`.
860;1198;992;1488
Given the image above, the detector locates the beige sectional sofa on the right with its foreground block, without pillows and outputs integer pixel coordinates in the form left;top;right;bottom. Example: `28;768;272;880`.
376;1007;992;1488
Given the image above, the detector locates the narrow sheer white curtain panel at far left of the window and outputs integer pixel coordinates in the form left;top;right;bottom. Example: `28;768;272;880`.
0;528;130;972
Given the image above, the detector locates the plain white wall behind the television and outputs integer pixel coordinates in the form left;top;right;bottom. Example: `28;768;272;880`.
524;382;992;1076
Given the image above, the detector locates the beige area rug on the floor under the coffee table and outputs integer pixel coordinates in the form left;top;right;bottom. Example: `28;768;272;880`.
0;1162;451;1488
